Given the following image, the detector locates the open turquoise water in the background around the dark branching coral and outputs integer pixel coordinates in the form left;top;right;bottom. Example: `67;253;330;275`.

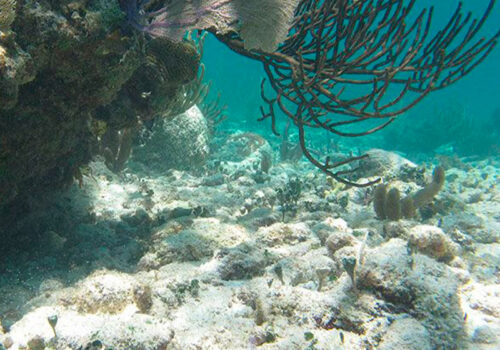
203;0;500;155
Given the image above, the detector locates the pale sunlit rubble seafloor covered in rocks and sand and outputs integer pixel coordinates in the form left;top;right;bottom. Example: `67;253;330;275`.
0;107;500;350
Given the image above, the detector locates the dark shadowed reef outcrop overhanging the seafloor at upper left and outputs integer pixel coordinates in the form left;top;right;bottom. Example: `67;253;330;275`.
0;1;199;206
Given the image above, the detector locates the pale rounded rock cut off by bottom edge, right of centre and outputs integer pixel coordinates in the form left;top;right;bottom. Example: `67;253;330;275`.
377;317;433;350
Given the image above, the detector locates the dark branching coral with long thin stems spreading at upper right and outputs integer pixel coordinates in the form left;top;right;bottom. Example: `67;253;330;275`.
214;0;500;186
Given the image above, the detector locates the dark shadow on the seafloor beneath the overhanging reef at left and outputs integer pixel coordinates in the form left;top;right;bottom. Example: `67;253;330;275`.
0;185;154;329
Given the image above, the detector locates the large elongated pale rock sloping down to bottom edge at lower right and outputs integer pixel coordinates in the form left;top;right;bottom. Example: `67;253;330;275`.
357;238;464;349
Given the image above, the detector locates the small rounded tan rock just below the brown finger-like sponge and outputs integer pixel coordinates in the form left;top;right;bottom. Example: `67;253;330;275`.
409;225;458;261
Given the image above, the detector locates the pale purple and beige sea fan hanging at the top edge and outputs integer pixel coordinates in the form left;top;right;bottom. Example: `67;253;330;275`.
120;0;299;52
